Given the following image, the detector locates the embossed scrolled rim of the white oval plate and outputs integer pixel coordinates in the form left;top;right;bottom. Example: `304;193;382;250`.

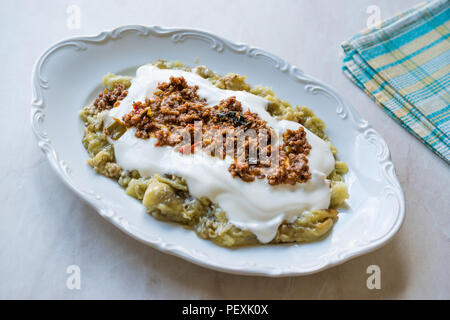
31;25;405;277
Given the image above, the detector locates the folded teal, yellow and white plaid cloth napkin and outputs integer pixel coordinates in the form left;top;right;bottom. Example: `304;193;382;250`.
342;0;450;164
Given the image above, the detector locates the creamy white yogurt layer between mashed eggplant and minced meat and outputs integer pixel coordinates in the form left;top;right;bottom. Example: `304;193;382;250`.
105;65;334;243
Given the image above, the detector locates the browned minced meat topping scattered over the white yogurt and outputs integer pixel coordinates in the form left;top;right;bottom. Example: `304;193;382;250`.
105;77;311;185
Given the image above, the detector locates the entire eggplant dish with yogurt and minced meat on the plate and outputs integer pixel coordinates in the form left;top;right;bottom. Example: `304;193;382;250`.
80;60;348;247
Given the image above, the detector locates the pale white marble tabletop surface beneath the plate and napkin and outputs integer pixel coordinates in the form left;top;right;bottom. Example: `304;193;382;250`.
0;0;450;299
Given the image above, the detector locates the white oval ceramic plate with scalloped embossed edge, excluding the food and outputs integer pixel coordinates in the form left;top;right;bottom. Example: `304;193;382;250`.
31;26;404;277
